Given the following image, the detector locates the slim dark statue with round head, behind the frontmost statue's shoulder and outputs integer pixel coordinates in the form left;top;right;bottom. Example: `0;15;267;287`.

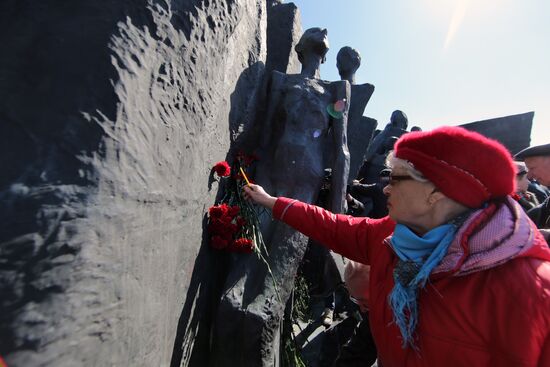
336;46;376;182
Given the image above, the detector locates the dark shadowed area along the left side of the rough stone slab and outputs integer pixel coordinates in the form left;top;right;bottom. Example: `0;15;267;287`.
0;0;164;358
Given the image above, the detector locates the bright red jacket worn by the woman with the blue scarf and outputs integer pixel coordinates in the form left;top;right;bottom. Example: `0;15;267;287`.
273;198;550;367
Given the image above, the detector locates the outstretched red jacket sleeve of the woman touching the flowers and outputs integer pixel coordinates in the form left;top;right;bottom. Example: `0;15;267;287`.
273;197;395;264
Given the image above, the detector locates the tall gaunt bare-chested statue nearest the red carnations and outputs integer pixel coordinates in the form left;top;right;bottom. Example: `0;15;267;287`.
212;28;350;366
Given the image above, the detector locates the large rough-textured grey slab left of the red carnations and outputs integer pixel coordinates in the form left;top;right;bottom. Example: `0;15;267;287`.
0;0;266;366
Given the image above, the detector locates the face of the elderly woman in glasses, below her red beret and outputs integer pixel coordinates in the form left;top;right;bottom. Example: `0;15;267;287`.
384;168;435;230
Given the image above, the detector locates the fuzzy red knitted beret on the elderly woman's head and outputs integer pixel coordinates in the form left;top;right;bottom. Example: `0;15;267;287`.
394;126;515;208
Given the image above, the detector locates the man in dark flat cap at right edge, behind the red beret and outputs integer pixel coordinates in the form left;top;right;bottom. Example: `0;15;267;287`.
514;144;550;240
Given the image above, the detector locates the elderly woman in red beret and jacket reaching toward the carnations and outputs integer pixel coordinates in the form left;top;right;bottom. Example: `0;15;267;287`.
245;127;550;367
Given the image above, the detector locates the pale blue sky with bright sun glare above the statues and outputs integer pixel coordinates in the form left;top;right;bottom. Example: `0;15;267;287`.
287;0;550;144
